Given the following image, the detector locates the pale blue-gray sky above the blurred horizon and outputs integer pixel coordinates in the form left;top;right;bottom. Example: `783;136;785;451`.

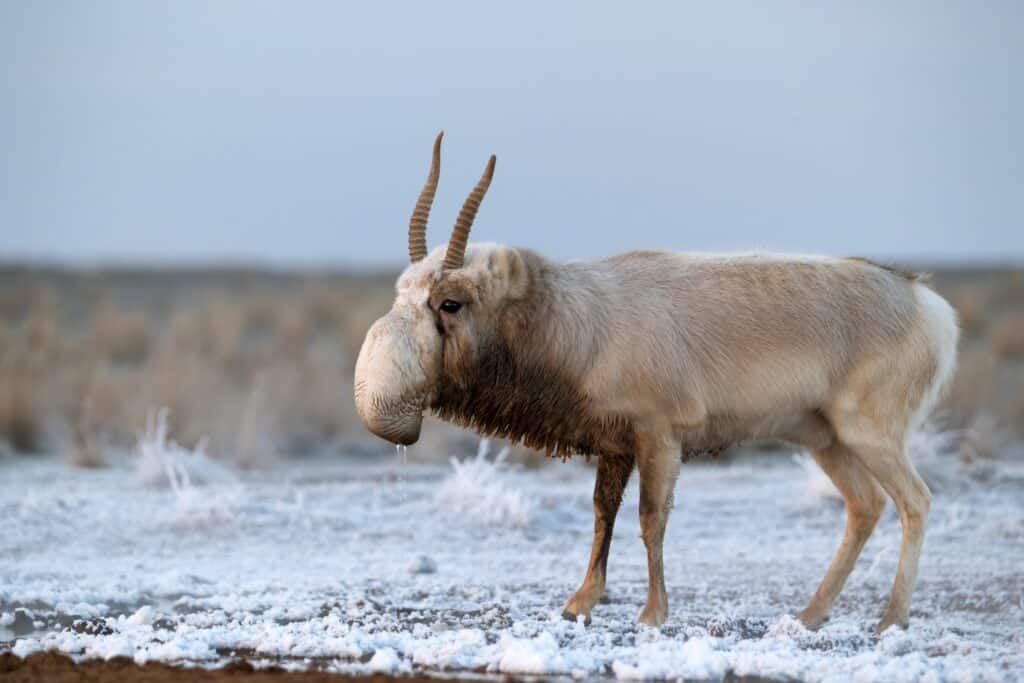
0;0;1024;265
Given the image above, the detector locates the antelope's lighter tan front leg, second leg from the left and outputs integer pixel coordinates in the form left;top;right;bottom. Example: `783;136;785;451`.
637;443;682;627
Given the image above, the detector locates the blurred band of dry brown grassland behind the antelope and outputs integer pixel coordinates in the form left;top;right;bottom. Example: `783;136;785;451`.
0;263;1024;467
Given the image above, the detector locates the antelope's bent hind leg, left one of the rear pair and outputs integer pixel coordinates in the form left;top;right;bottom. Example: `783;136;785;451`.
797;442;886;629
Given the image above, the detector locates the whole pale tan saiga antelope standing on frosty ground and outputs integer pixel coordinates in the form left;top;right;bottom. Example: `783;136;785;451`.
355;135;958;631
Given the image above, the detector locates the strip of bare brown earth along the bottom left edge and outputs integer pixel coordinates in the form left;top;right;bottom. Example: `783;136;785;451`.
0;652;465;683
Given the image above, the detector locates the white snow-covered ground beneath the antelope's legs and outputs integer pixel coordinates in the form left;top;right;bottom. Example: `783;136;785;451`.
0;440;1024;681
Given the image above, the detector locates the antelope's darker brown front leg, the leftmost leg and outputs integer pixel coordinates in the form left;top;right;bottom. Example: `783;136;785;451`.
562;456;634;624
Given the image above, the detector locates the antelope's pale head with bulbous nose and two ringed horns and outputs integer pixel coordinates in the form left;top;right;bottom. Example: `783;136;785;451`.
354;133;525;444
